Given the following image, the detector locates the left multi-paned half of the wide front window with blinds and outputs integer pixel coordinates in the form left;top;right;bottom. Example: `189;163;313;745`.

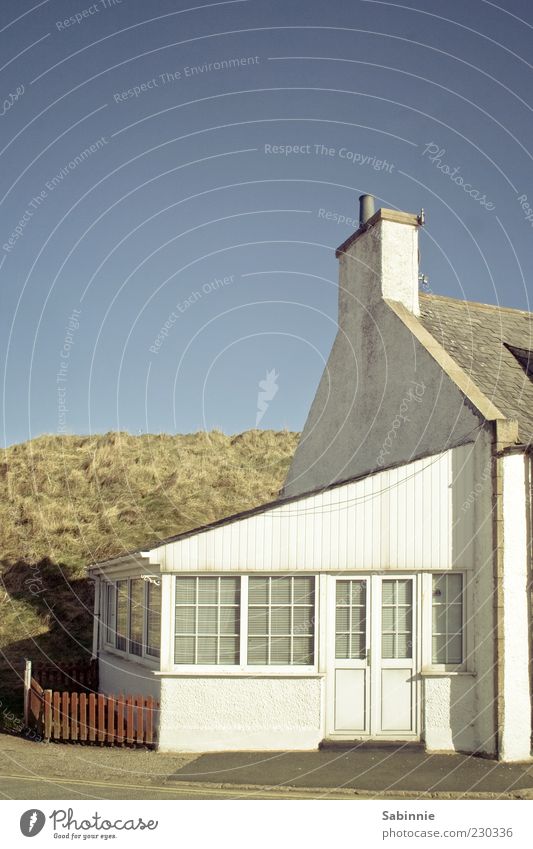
174;577;240;665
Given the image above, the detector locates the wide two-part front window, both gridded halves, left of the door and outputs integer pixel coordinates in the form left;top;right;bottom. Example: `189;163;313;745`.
174;576;315;667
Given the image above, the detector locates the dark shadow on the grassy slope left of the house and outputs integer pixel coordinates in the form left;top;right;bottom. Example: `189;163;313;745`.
0;558;94;728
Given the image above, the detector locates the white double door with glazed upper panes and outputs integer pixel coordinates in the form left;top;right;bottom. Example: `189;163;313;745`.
327;575;420;740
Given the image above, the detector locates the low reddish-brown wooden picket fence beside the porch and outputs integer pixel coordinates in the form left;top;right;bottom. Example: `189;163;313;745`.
29;678;159;746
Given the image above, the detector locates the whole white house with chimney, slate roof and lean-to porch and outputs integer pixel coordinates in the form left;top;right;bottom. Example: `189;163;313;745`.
90;196;533;761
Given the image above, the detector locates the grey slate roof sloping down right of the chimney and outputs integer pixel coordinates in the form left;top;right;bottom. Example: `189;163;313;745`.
420;294;533;445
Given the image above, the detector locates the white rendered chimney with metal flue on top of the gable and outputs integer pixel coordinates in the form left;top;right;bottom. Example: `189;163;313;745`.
336;195;423;318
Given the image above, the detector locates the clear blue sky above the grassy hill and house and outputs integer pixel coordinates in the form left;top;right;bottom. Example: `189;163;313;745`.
0;0;533;444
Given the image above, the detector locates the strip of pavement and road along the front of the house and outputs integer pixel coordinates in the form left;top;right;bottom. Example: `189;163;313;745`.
0;734;533;800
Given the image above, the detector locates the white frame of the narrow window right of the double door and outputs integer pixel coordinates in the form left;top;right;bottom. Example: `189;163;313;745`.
422;569;473;675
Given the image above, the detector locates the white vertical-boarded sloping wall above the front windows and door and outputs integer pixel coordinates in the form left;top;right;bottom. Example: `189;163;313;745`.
150;445;476;572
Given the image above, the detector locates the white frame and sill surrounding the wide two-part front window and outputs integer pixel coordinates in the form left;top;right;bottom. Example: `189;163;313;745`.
167;571;320;678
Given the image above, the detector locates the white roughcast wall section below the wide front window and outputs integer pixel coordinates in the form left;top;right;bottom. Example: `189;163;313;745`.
159;675;324;752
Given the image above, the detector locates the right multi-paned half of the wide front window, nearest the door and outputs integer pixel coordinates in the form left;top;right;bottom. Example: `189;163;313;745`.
248;577;315;666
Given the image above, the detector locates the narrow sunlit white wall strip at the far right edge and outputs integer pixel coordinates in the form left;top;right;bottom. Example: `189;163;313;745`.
500;454;531;761
